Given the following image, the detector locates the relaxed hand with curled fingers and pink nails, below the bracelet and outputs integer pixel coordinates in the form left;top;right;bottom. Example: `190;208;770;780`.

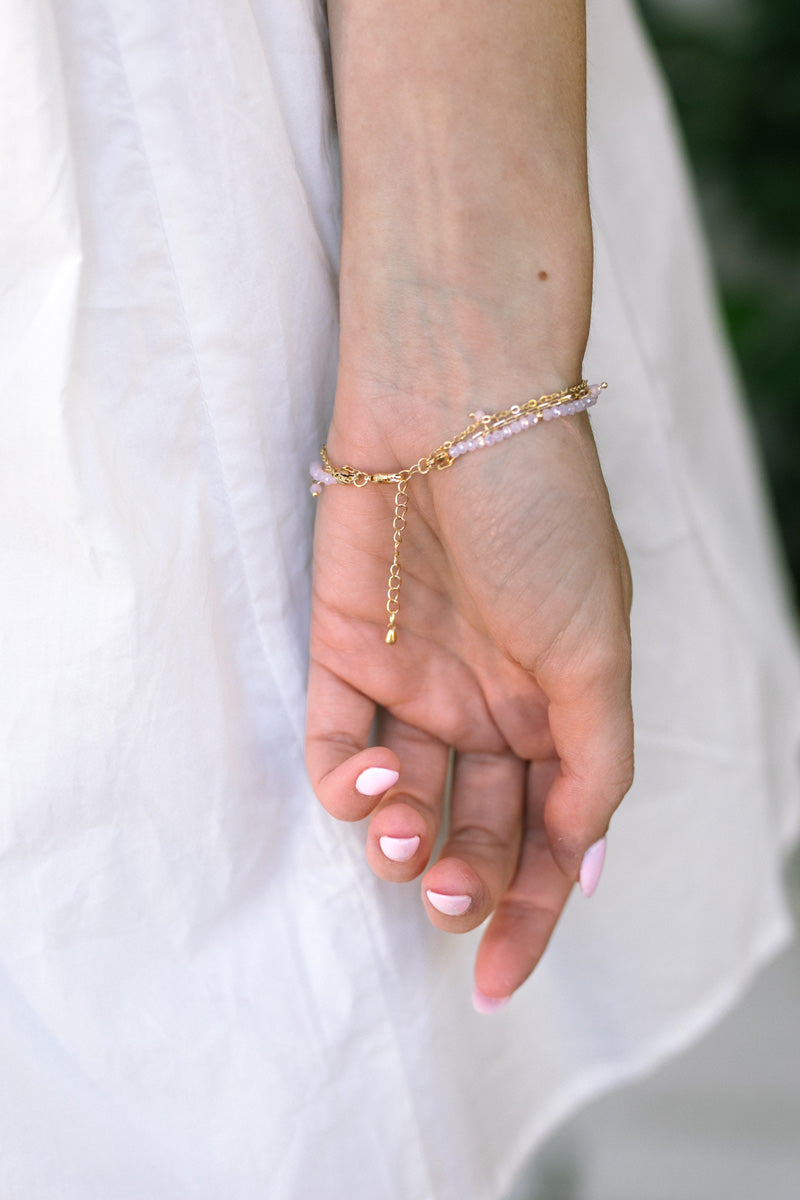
307;388;632;1000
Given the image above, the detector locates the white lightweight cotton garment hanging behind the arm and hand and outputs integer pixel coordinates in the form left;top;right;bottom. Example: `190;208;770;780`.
0;0;800;1200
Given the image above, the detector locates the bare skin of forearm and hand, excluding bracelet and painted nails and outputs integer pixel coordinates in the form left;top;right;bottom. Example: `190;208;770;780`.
307;0;632;997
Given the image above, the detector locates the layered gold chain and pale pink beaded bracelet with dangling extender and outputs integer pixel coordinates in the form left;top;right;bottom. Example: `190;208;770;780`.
311;379;607;646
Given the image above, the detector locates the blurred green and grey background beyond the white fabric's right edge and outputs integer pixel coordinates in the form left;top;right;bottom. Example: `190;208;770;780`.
512;0;800;1200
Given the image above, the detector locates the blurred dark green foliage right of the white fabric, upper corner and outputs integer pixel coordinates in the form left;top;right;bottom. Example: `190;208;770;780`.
639;0;800;595
